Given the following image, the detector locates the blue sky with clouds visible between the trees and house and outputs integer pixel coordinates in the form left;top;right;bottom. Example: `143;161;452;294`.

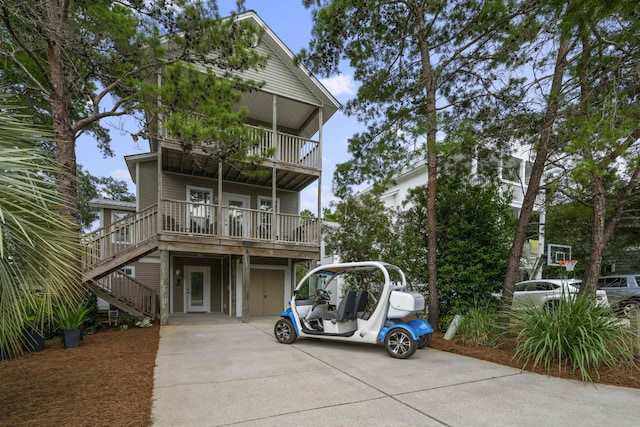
76;0;363;212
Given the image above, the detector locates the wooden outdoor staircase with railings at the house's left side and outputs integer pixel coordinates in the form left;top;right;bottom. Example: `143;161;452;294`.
81;205;158;318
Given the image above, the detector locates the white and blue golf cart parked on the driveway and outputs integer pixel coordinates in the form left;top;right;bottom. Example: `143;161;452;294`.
274;261;433;359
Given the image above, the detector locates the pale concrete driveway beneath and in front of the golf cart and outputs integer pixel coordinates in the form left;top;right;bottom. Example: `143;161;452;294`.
152;316;640;427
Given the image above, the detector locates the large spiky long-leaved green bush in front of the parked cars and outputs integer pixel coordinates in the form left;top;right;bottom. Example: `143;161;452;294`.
511;294;637;381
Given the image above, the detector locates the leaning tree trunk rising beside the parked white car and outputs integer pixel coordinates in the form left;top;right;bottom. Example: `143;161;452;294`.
502;39;570;314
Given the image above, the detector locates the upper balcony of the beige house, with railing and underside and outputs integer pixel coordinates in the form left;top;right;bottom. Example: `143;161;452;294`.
159;125;322;191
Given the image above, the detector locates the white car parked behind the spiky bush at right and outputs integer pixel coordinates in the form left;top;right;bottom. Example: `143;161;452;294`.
513;279;609;308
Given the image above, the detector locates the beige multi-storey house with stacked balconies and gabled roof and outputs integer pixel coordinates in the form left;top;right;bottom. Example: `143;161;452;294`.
83;11;340;324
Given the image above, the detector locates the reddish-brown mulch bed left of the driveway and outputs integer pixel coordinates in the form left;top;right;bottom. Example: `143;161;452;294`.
0;325;160;427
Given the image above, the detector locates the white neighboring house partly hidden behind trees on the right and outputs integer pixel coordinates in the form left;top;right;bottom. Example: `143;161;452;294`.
361;145;545;279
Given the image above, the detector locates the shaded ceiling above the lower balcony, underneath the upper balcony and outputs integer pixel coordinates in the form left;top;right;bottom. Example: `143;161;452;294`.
162;148;319;191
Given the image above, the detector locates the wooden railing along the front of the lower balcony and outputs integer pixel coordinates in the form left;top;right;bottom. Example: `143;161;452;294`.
161;200;319;245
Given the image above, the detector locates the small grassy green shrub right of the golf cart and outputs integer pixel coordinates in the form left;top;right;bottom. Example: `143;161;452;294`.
457;307;500;347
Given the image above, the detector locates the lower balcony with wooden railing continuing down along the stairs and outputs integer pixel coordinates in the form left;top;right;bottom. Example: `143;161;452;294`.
81;200;320;269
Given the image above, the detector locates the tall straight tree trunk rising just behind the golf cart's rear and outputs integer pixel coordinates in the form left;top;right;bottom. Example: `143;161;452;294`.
417;11;440;329
